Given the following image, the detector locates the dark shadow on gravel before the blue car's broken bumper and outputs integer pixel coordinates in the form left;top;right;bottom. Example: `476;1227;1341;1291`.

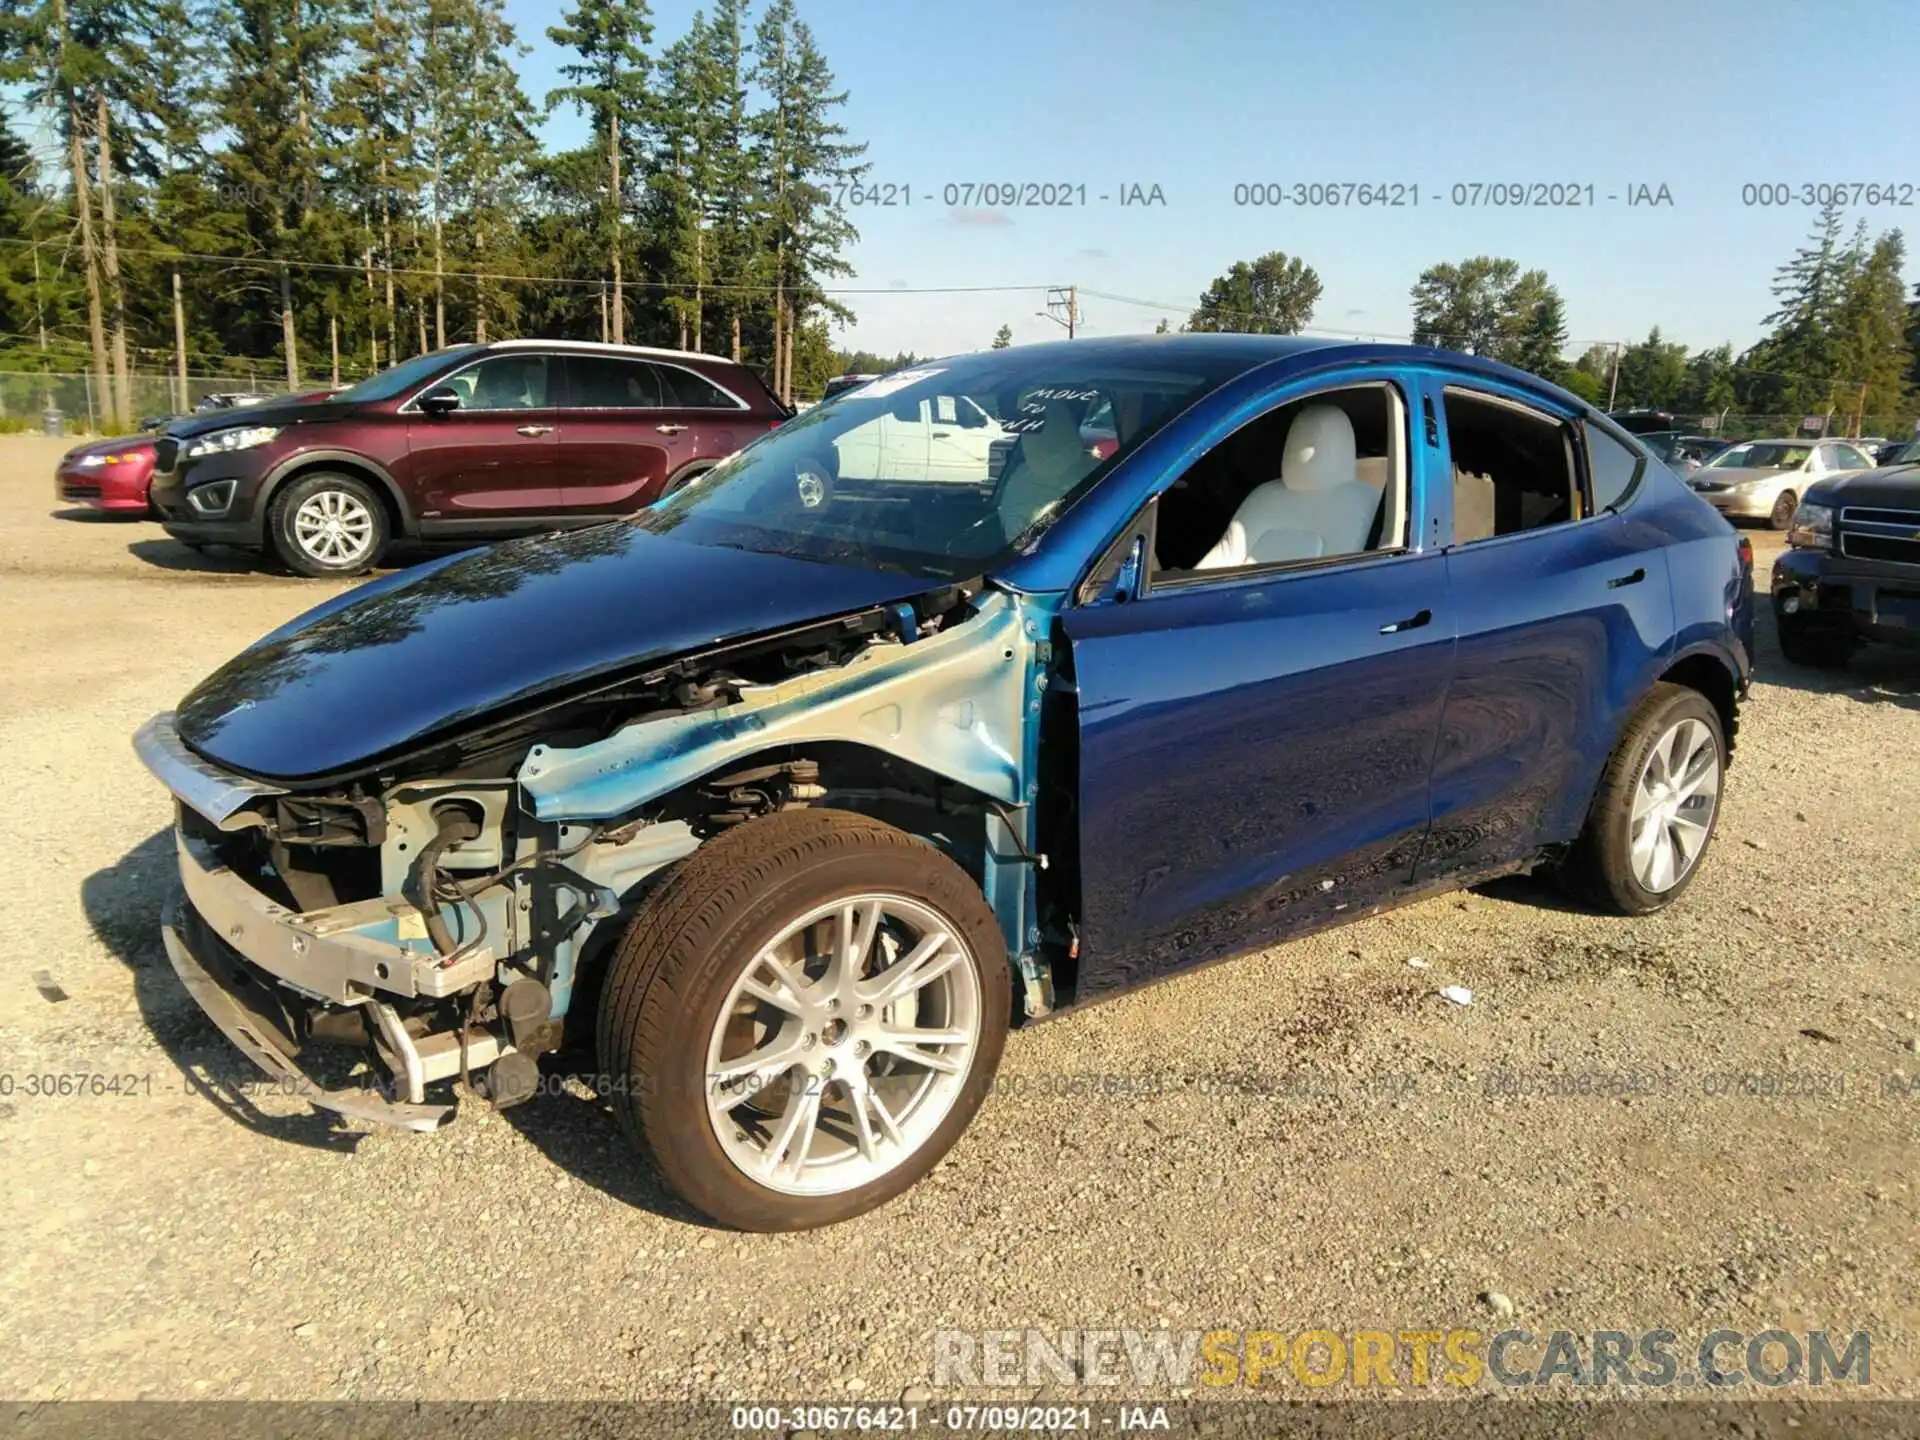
81;829;365;1152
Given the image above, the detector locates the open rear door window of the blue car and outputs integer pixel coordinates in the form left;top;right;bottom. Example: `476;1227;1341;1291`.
1446;390;1580;545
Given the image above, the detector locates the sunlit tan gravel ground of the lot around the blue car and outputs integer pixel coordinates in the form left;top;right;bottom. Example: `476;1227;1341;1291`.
0;438;1920;1402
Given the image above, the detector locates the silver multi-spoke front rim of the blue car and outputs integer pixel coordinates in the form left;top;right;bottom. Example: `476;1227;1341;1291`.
705;893;981;1196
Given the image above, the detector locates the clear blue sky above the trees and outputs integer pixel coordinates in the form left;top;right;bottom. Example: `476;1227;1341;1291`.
507;0;1920;353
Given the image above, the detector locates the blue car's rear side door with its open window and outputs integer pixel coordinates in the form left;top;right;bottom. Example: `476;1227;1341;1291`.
1419;376;1672;883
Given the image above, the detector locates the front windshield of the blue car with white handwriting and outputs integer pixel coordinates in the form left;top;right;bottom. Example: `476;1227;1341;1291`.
637;346;1248;580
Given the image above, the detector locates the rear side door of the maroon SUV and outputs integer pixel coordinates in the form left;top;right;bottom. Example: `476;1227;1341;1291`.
561;353;695;516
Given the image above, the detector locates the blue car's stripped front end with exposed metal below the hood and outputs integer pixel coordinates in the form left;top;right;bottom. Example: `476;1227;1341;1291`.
136;586;1052;1129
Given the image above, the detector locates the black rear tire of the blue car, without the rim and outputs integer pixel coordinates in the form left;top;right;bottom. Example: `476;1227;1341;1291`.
1559;684;1726;916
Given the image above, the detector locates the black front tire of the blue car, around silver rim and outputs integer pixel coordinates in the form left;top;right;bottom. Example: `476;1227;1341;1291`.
597;810;1012;1231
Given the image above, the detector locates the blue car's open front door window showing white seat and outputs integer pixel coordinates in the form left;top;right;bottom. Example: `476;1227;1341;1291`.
1154;382;1407;584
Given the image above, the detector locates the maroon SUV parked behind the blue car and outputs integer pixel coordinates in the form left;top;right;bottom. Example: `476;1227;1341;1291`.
140;340;789;576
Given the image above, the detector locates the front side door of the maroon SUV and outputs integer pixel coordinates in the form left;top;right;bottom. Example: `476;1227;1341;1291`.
401;351;561;534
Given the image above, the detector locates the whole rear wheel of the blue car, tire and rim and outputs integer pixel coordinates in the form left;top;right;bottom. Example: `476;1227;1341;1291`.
1561;684;1726;916
